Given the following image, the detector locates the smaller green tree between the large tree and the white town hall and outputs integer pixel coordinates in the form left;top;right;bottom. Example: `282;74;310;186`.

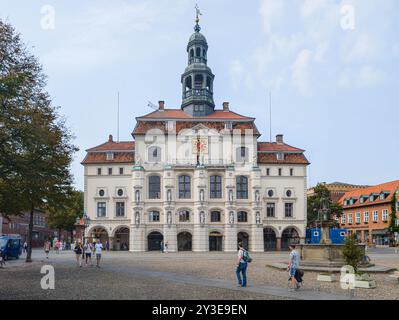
47;190;83;239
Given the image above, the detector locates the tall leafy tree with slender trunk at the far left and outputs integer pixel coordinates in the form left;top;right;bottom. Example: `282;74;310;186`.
0;20;78;262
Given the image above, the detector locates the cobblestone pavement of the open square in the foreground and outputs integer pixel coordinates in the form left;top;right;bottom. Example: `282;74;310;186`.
0;250;399;300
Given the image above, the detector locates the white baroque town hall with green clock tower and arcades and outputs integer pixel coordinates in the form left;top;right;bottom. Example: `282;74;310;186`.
82;16;309;252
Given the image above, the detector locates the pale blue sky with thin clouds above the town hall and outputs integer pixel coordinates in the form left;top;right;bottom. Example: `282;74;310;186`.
0;0;399;190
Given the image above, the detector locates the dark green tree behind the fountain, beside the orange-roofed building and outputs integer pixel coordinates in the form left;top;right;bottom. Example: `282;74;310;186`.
307;183;343;225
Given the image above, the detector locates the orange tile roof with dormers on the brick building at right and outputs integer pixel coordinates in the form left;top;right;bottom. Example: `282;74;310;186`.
339;180;399;208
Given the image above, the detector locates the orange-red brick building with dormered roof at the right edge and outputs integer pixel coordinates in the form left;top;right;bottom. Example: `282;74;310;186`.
339;180;399;245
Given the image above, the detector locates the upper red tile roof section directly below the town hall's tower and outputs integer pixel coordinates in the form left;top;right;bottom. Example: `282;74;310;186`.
137;109;254;120
